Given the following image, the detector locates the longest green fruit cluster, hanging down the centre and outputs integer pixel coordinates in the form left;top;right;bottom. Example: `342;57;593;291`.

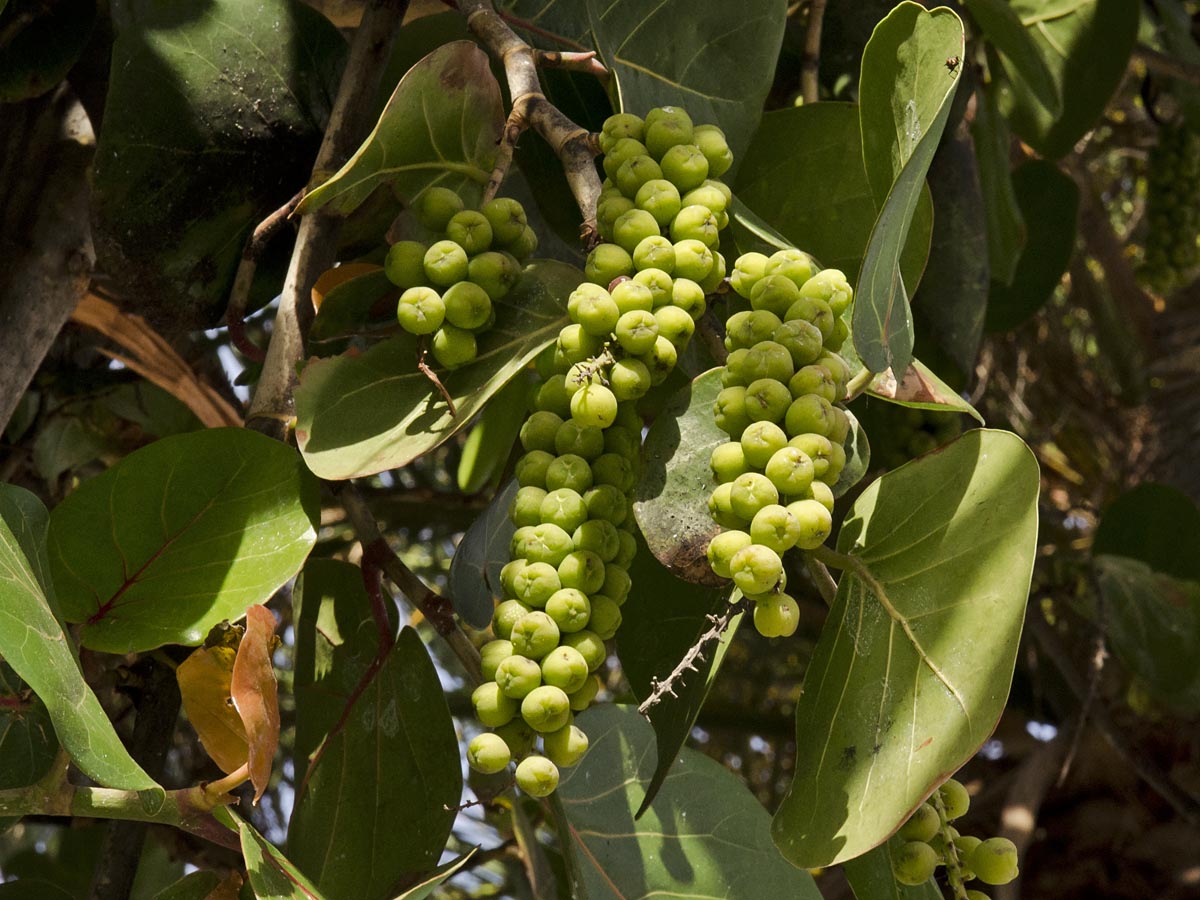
467;108;730;797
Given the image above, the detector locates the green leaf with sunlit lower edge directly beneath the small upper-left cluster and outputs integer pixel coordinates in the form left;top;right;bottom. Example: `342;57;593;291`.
295;260;583;480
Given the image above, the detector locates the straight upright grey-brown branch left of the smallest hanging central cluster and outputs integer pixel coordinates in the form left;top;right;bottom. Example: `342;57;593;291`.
247;0;408;438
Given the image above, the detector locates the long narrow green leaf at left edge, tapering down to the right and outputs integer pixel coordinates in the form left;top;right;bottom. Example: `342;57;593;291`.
0;485;162;796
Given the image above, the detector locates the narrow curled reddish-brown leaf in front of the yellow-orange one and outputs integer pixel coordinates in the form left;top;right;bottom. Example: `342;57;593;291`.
229;605;280;803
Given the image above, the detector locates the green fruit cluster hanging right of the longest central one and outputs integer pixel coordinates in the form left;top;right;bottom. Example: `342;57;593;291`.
708;250;853;637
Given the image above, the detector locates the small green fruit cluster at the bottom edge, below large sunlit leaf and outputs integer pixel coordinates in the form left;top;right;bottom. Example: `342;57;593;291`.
892;778;1019;900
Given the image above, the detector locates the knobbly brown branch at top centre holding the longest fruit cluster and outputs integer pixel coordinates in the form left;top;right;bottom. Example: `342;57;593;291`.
458;0;600;246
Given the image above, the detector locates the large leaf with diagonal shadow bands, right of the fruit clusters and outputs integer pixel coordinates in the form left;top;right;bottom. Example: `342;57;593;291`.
773;430;1039;866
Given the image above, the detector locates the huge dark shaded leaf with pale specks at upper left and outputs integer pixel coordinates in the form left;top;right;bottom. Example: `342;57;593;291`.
94;0;346;326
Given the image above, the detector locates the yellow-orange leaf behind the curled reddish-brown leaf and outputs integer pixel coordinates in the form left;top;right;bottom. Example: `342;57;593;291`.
175;646;250;773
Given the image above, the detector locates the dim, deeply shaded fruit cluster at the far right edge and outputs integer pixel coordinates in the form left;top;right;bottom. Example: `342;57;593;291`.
1139;122;1200;294
